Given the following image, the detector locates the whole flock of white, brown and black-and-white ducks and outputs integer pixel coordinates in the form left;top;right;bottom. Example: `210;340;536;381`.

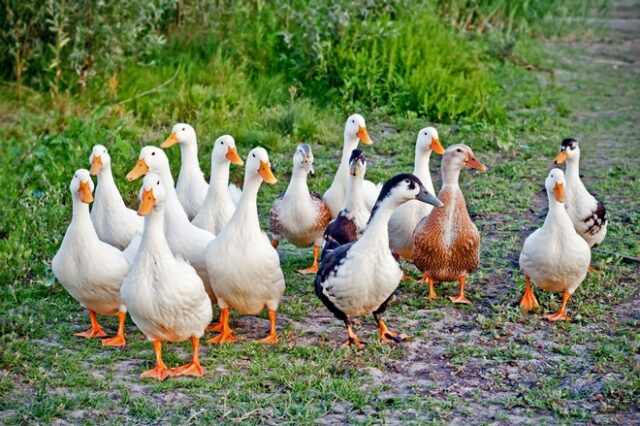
52;114;607;380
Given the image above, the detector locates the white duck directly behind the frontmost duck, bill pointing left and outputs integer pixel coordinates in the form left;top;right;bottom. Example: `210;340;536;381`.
127;146;216;303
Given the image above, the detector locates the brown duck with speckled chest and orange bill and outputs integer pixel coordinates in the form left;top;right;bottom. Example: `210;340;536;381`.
412;144;487;304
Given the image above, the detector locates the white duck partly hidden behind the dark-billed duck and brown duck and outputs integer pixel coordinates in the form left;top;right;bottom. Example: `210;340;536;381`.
389;127;444;261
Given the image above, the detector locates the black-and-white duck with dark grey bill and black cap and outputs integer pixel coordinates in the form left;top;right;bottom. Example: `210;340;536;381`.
314;174;442;346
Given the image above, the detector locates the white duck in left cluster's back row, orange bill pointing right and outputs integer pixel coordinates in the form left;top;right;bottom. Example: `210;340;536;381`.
191;135;244;234
